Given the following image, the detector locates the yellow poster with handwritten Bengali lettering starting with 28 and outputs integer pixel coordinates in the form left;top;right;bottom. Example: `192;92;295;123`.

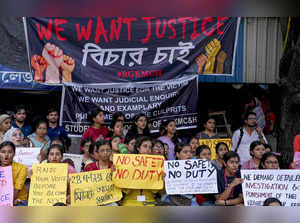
70;169;122;206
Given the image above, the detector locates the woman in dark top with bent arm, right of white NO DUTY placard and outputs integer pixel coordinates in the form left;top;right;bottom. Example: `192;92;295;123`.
216;151;243;206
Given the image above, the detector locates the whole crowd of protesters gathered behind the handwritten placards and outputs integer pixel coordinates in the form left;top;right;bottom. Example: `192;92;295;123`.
0;99;295;206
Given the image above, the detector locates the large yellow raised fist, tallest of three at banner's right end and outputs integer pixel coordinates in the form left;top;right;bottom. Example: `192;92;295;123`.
204;39;221;74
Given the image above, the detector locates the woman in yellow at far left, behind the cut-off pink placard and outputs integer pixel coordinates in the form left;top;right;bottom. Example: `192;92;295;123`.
0;141;27;206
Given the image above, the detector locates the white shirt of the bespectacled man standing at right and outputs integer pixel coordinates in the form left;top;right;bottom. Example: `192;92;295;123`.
232;128;268;164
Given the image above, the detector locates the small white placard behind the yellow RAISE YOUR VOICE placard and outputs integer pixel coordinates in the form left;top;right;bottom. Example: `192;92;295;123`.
14;147;41;170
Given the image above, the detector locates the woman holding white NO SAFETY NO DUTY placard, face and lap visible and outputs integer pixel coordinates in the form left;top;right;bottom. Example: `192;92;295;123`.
162;143;198;206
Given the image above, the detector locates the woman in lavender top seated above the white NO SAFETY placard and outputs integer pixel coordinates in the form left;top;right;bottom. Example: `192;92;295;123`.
158;119;181;160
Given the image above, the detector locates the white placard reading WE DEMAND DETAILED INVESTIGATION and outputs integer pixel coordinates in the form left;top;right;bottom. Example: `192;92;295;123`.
241;170;300;206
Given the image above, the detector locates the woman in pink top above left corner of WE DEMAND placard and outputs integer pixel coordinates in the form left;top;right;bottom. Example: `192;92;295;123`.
242;141;266;170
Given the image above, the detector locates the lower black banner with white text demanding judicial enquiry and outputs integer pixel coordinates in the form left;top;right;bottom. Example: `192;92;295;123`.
60;75;198;136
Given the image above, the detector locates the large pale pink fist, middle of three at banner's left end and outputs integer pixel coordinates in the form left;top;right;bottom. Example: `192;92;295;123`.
43;43;63;84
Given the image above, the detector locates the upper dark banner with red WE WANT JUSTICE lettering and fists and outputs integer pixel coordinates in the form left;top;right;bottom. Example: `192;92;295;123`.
25;16;240;84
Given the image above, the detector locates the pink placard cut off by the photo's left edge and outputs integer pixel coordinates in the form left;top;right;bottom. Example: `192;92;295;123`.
0;166;14;206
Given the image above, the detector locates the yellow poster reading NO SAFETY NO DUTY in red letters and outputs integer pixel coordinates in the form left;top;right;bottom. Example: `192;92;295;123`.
113;154;164;190
